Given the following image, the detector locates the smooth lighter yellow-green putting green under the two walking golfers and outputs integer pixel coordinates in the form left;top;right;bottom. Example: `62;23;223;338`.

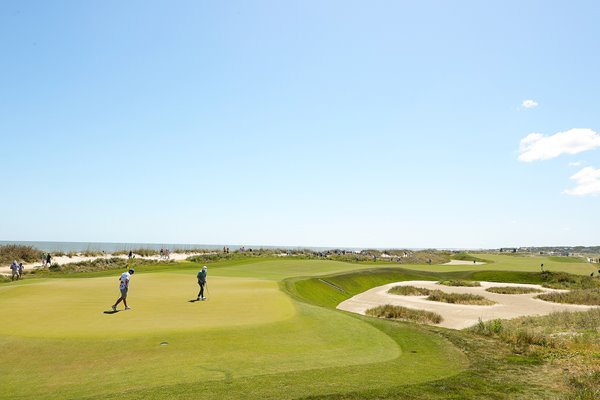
0;273;295;338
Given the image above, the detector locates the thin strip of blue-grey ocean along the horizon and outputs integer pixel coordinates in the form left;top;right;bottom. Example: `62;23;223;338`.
0;240;342;253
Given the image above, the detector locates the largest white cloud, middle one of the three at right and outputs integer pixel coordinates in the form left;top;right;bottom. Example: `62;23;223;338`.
519;128;600;162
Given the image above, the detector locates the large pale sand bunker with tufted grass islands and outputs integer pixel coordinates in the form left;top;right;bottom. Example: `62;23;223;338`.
337;281;593;329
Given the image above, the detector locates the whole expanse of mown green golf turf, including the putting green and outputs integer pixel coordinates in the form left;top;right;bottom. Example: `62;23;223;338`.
0;257;600;400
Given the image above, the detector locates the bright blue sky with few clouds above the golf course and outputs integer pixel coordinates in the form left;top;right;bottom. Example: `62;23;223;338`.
0;1;600;248
